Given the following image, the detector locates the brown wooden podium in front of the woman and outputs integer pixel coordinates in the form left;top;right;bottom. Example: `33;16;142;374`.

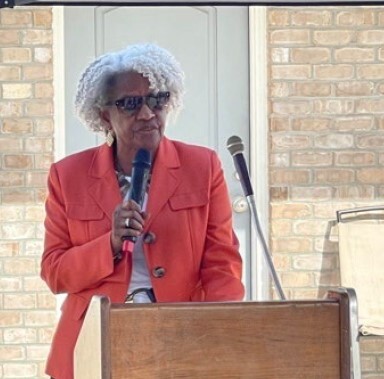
74;289;360;379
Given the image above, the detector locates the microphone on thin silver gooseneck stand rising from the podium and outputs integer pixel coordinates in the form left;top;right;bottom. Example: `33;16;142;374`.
227;136;286;300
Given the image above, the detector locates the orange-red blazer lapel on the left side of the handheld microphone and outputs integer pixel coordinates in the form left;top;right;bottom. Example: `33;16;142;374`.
88;144;121;223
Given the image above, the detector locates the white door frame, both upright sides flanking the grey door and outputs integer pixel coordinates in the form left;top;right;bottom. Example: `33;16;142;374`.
52;6;271;301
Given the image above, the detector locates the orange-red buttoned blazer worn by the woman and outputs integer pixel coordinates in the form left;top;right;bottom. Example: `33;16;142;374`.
41;137;244;379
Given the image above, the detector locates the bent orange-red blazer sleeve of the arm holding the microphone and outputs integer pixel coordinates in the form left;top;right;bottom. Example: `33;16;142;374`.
41;164;114;293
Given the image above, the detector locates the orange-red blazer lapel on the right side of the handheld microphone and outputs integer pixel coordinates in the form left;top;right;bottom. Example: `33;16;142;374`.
146;137;180;229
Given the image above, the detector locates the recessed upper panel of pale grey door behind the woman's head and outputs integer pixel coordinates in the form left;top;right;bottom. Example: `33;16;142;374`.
96;7;218;146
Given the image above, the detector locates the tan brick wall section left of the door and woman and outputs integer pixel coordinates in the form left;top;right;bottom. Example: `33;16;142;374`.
0;7;56;379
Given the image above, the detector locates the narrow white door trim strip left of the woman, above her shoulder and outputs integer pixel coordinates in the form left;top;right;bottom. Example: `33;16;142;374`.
52;6;66;161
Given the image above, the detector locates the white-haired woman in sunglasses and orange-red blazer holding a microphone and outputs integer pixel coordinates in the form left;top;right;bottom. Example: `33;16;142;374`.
41;44;244;379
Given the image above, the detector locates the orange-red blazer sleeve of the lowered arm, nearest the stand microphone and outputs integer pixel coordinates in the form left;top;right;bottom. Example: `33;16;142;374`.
200;152;244;301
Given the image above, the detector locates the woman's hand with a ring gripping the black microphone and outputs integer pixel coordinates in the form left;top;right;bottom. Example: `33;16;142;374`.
111;200;147;257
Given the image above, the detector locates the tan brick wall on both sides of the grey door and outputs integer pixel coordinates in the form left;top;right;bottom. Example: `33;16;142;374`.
0;3;384;379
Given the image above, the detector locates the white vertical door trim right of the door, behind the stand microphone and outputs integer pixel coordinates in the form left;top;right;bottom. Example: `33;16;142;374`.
249;6;271;300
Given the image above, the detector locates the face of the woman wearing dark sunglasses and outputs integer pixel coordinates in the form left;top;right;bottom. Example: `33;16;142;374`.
101;72;168;154
